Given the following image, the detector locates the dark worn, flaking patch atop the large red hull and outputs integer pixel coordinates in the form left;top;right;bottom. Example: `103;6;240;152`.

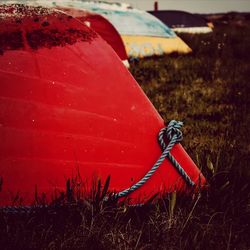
0;4;97;55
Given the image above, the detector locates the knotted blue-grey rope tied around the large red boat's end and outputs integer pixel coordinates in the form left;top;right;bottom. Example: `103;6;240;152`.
115;120;194;198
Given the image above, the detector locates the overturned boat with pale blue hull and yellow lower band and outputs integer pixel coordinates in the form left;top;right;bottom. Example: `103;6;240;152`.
31;0;191;58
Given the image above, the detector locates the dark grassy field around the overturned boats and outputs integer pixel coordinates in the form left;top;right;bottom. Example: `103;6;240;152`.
0;16;250;250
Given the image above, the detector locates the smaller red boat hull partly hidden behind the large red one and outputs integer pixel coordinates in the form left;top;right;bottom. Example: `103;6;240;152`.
57;8;128;61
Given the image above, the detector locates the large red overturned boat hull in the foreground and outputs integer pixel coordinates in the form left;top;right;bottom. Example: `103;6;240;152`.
0;7;205;205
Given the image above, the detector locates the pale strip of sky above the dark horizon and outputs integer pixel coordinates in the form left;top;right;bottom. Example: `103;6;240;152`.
103;0;250;13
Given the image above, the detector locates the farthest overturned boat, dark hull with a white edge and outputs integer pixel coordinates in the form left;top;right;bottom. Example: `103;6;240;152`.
149;10;213;34
